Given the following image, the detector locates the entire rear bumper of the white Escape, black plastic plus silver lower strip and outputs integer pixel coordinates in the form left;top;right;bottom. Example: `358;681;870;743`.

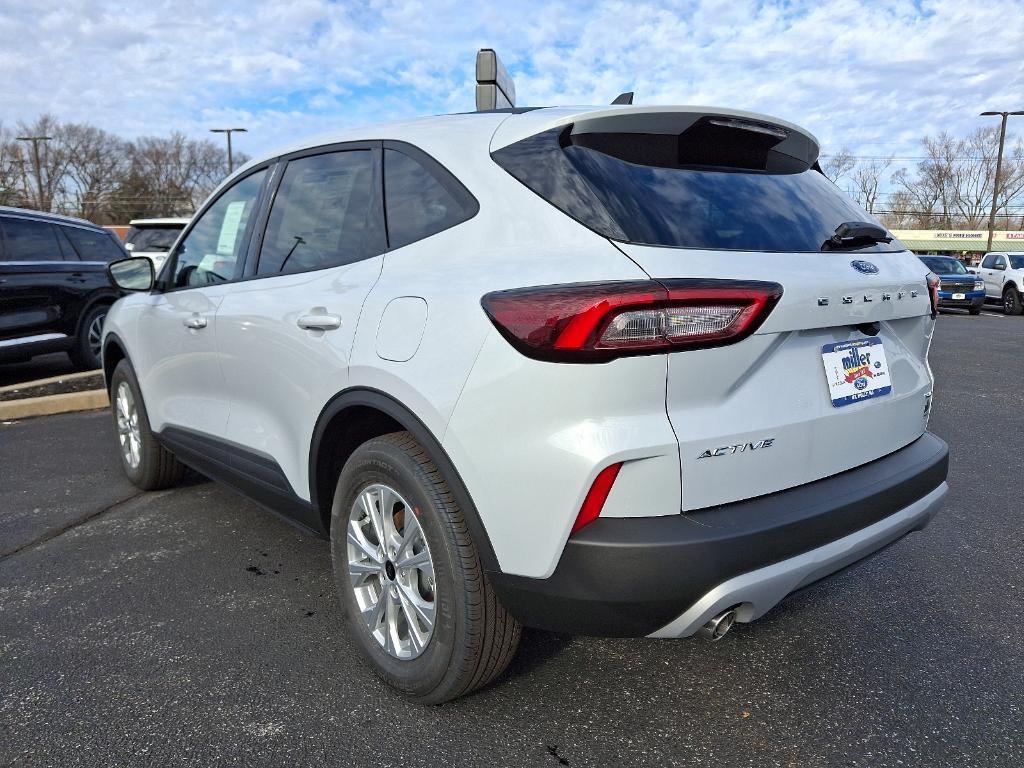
488;433;948;637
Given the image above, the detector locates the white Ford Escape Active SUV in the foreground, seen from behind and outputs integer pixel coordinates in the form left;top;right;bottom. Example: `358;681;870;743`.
103;106;947;701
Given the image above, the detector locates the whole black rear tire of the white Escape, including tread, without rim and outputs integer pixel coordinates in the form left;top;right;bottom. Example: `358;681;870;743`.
331;432;521;703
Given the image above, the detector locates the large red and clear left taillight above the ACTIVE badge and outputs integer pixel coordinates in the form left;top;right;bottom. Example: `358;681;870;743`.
481;280;782;362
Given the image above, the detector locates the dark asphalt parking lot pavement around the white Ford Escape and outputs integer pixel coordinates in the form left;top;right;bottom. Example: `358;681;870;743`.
0;314;1024;766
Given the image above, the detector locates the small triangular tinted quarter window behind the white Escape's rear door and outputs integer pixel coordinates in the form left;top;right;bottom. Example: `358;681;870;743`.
384;148;479;249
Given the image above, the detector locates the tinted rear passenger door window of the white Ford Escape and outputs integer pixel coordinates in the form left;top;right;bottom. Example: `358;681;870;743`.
256;150;384;276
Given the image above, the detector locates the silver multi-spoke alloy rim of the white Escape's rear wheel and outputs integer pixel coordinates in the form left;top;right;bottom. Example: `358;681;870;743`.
346;483;436;660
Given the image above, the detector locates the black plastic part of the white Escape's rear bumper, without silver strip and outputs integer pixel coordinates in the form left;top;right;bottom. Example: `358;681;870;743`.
488;432;949;637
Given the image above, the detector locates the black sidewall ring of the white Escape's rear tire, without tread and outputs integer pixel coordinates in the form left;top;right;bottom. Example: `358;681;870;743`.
331;440;465;696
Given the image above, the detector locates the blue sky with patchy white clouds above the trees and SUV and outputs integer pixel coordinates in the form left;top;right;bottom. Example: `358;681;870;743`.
0;0;1024;162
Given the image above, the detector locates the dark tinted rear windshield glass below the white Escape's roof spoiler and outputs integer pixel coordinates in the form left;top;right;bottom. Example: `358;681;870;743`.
492;126;904;252
